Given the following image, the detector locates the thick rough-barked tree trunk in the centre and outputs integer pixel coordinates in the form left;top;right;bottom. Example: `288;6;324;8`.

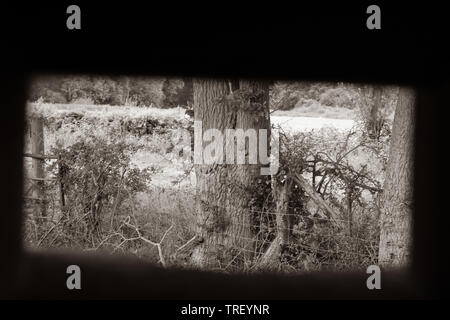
192;79;270;269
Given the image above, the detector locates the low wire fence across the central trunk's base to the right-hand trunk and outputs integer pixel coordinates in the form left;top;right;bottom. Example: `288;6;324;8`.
185;191;379;269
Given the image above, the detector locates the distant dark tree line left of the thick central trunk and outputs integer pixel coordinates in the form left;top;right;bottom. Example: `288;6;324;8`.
28;75;192;108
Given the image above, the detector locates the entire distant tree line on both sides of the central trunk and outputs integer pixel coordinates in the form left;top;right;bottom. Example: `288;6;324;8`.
28;75;397;119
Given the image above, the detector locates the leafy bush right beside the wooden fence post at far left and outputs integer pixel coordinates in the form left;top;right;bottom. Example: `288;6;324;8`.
49;136;151;246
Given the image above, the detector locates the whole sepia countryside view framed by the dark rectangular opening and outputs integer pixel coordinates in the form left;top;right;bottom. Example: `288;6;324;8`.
22;74;416;274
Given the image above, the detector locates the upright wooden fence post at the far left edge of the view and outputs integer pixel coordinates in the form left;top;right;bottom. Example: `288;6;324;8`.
30;116;46;216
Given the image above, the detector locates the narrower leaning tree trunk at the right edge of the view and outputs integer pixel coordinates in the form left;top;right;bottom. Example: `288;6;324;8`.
378;88;416;266
